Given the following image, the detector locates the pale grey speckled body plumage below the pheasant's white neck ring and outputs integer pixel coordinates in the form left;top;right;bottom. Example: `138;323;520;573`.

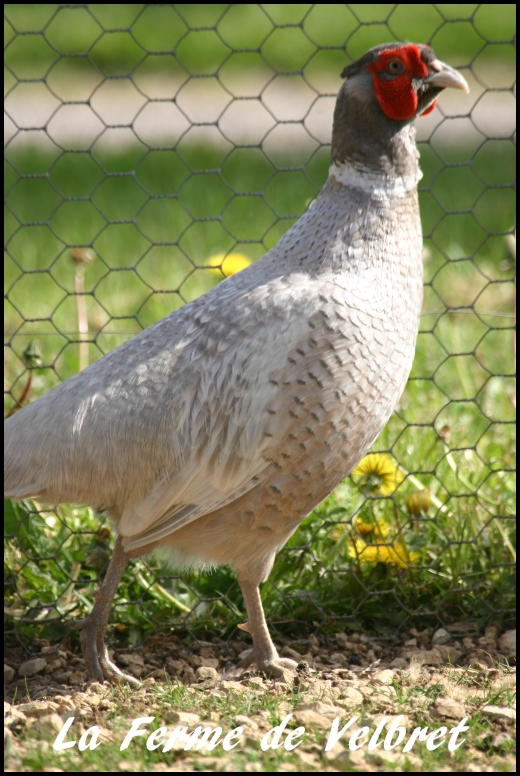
6;171;422;563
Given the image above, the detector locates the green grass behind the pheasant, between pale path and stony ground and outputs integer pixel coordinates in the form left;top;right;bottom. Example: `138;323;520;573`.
6;133;515;644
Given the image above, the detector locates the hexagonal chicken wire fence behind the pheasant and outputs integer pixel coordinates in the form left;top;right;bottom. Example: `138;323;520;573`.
4;4;515;657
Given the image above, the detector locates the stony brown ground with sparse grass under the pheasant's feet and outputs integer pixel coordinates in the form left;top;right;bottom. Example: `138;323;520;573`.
5;623;516;772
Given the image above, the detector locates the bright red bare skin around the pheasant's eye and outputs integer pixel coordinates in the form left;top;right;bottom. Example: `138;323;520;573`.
367;45;435;121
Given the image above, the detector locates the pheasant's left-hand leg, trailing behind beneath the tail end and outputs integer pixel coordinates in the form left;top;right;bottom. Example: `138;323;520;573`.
67;537;140;686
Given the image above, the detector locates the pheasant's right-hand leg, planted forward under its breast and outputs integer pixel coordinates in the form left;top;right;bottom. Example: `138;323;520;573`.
237;577;298;677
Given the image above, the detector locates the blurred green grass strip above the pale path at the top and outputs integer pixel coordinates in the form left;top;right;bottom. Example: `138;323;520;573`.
4;3;515;86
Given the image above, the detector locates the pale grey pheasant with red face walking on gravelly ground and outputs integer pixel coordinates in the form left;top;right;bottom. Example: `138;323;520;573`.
5;43;468;681
